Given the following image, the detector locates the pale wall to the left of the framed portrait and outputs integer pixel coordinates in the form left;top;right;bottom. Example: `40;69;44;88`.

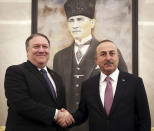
0;0;31;125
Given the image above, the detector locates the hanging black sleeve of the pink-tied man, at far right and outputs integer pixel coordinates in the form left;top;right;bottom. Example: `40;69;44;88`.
135;79;151;131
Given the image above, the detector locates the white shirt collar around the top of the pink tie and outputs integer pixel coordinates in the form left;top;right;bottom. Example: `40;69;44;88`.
100;68;119;82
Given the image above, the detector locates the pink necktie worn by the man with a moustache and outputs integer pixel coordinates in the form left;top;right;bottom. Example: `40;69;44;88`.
104;76;113;115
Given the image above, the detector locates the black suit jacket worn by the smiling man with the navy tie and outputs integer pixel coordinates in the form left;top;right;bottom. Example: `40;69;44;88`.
5;61;65;131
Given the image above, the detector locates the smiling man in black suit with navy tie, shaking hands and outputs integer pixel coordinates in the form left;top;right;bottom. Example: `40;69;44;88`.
4;33;73;131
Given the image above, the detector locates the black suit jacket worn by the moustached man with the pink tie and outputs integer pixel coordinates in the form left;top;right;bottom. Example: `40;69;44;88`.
74;72;151;131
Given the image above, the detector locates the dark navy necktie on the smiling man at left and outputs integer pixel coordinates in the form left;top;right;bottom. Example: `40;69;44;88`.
40;69;56;100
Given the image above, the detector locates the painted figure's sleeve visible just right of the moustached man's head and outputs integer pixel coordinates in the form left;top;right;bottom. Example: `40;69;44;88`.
118;49;128;72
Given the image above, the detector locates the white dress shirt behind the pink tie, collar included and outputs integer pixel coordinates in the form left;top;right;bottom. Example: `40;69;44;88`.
99;68;119;106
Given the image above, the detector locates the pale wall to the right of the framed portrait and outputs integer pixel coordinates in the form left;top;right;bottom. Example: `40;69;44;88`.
138;0;154;126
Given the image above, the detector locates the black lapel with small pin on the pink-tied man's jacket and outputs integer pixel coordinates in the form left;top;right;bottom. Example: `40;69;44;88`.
110;72;127;115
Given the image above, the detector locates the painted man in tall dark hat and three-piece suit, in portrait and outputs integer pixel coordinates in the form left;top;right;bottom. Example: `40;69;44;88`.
53;0;127;131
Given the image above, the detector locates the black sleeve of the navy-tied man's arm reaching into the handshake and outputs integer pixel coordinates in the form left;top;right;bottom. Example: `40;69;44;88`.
4;66;55;125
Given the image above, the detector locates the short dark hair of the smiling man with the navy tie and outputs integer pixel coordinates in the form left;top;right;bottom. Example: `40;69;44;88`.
25;33;50;48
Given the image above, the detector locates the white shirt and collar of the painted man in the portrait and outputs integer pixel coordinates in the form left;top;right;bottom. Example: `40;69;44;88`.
74;34;92;64
